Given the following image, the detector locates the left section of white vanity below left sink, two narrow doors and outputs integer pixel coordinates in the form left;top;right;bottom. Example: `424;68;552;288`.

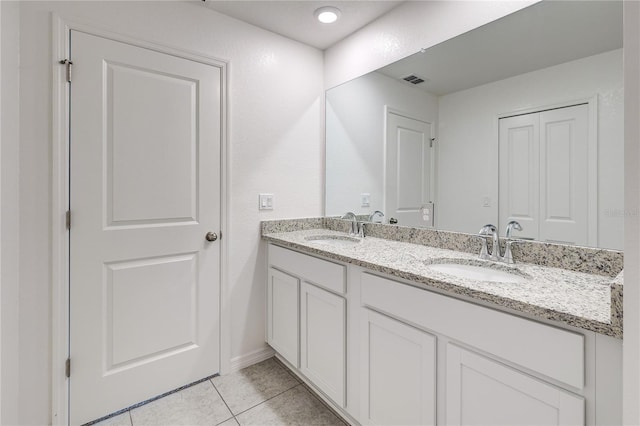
267;245;347;407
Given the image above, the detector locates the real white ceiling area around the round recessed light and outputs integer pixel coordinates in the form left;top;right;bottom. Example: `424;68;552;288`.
204;0;403;50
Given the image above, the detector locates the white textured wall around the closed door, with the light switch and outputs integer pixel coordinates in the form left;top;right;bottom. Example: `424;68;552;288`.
9;1;323;424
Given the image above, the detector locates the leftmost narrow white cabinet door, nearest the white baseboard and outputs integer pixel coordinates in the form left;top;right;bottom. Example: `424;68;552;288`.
267;268;300;368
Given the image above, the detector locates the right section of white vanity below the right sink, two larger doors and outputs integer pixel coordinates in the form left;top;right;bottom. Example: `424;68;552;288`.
360;270;620;425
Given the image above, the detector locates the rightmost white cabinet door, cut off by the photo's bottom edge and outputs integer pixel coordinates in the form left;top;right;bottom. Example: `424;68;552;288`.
445;344;585;426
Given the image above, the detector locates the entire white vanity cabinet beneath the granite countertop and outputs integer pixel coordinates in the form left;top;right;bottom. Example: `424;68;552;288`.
267;244;622;426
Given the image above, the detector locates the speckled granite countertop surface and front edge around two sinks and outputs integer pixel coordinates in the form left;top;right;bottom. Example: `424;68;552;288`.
262;228;622;338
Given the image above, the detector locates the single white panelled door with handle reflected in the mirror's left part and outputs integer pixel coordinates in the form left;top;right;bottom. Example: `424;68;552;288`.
384;111;433;227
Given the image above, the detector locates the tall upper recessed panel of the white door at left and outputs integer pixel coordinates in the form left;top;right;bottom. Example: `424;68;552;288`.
104;62;198;225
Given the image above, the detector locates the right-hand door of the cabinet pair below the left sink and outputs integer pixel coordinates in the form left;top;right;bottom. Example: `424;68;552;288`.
300;282;347;407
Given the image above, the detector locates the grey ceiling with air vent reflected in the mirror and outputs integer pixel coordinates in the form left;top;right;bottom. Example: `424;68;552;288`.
379;1;622;95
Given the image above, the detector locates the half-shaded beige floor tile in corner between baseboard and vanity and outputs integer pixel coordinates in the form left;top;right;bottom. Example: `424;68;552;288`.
211;358;300;414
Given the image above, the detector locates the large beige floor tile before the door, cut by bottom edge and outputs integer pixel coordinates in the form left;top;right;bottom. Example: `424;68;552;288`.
131;380;233;426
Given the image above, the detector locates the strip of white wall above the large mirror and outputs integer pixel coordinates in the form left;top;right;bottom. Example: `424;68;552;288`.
324;0;539;88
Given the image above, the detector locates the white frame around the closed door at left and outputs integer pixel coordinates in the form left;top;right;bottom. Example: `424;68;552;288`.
51;14;231;425
